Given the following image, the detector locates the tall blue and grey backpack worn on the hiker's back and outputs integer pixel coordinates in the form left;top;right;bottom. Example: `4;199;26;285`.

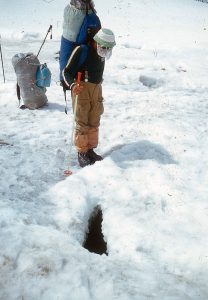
59;6;101;84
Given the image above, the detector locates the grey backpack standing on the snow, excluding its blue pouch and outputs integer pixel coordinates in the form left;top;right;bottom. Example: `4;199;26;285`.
12;53;48;109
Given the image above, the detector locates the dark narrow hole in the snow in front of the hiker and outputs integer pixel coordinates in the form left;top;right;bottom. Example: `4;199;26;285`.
83;206;108;255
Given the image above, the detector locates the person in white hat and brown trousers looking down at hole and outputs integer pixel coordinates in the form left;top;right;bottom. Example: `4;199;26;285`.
62;28;116;167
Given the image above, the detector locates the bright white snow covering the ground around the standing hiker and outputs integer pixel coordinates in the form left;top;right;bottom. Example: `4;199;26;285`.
0;0;208;300
